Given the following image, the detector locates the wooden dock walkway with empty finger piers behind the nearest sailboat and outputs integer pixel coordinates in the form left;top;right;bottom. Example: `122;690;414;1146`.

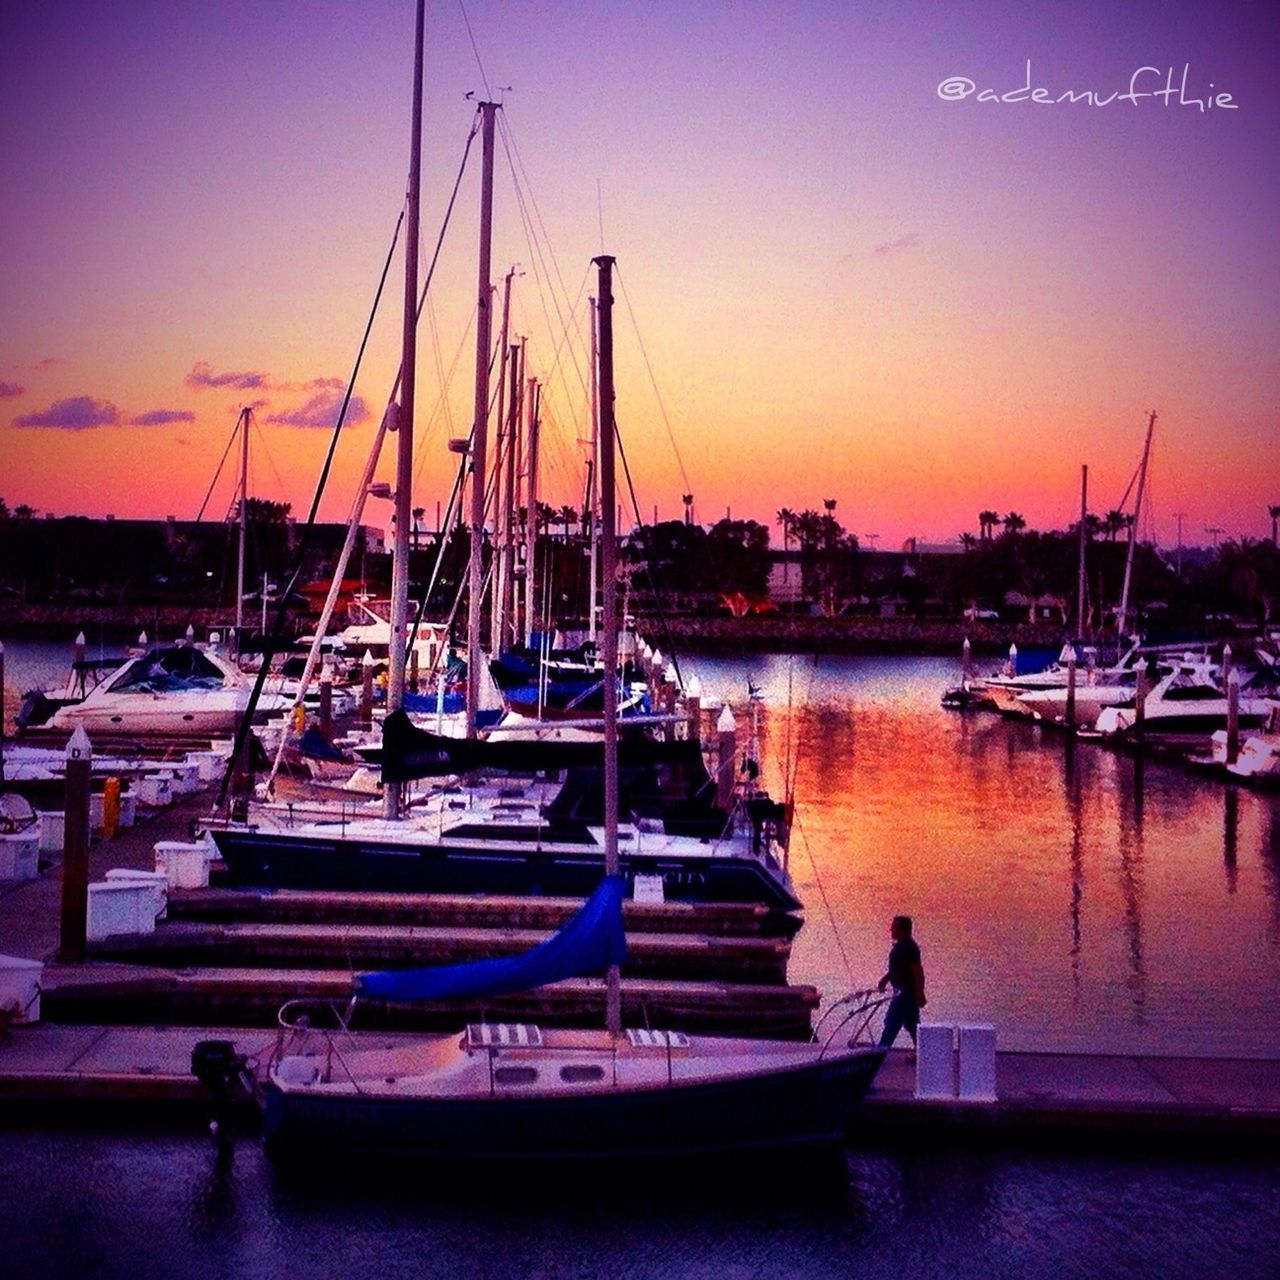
0;768;1280;1143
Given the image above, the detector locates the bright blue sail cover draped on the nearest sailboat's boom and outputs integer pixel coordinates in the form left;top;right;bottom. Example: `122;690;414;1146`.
356;876;627;1001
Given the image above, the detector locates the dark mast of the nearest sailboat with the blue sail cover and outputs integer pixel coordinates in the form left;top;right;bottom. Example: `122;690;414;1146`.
593;255;622;1036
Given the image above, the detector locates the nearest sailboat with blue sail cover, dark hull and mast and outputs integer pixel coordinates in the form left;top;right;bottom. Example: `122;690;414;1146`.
230;244;884;1161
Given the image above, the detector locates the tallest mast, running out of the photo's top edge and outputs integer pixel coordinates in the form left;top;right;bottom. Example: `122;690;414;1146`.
383;0;425;818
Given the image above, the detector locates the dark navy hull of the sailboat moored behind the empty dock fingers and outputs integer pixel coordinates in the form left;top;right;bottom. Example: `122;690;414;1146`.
212;831;801;911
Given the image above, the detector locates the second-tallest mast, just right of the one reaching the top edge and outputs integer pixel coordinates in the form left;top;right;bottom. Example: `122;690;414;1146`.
467;102;498;737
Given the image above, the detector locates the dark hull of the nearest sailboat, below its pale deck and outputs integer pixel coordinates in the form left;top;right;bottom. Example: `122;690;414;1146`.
264;1047;884;1162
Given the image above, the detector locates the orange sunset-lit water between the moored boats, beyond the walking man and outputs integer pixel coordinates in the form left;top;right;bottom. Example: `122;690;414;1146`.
698;658;1280;1055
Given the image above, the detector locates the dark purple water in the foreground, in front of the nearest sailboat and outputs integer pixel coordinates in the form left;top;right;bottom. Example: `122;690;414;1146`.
0;1132;1280;1280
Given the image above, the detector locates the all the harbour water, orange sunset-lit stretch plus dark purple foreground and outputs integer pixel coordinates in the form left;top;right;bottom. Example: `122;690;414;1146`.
0;644;1280;1280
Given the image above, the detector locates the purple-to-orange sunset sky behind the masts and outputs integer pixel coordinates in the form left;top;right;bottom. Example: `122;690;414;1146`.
0;0;1280;548
